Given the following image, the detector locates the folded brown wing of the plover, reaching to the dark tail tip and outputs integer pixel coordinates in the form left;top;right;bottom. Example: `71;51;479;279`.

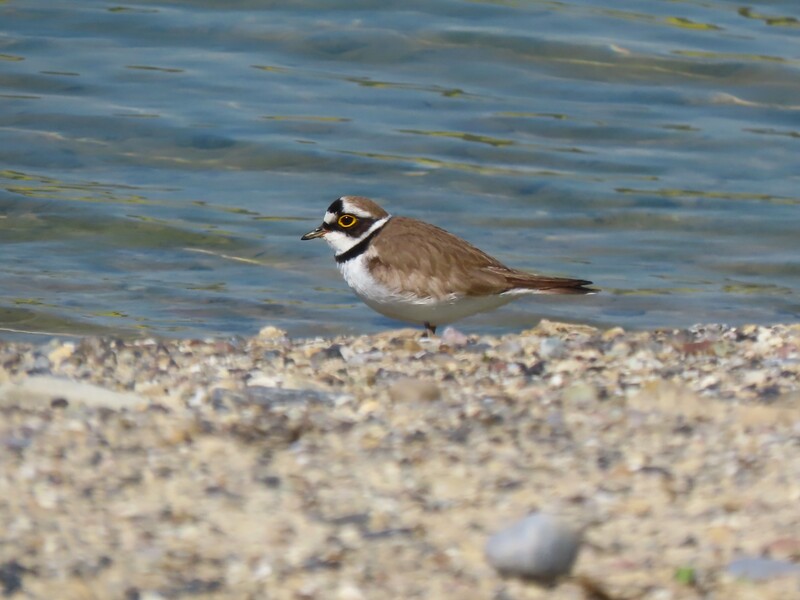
369;217;591;298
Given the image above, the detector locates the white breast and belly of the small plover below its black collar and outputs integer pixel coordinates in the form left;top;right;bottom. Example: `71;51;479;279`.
339;253;533;325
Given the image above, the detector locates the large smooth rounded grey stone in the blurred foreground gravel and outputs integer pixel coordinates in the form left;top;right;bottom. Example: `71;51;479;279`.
486;513;582;582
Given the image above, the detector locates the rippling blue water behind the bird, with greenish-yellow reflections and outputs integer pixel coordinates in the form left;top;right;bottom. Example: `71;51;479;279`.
0;0;800;338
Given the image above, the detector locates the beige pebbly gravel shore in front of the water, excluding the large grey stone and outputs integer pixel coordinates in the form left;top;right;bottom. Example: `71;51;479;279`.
0;321;800;600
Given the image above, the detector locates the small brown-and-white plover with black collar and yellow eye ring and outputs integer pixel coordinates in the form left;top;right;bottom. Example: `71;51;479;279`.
300;196;598;337
